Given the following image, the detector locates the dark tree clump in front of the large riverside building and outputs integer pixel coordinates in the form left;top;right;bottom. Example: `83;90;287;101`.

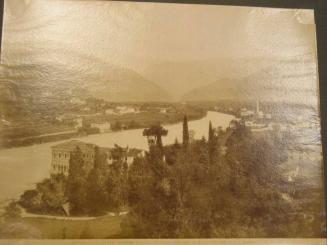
19;146;127;216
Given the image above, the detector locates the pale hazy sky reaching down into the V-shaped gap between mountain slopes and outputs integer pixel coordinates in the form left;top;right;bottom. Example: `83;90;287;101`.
2;0;317;102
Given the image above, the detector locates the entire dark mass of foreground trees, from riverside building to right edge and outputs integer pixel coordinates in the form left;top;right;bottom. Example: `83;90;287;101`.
11;117;324;238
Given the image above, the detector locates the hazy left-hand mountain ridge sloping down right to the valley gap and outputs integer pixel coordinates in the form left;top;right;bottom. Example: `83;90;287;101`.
0;61;171;102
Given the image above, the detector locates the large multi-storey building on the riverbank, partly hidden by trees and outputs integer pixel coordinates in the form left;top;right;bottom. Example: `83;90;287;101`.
50;140;144;176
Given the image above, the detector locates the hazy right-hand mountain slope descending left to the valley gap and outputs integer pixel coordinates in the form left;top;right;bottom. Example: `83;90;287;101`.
182;64;318;104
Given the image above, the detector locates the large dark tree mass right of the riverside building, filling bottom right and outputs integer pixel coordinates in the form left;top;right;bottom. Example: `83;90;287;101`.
122;122;323;238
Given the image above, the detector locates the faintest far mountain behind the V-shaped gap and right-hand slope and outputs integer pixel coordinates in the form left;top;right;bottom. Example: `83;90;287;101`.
140;53;316;99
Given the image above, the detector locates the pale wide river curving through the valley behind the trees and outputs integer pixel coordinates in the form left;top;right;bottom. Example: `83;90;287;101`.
0;111;234;206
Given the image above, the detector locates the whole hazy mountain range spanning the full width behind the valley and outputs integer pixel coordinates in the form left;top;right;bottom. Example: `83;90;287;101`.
0;50;318;109
